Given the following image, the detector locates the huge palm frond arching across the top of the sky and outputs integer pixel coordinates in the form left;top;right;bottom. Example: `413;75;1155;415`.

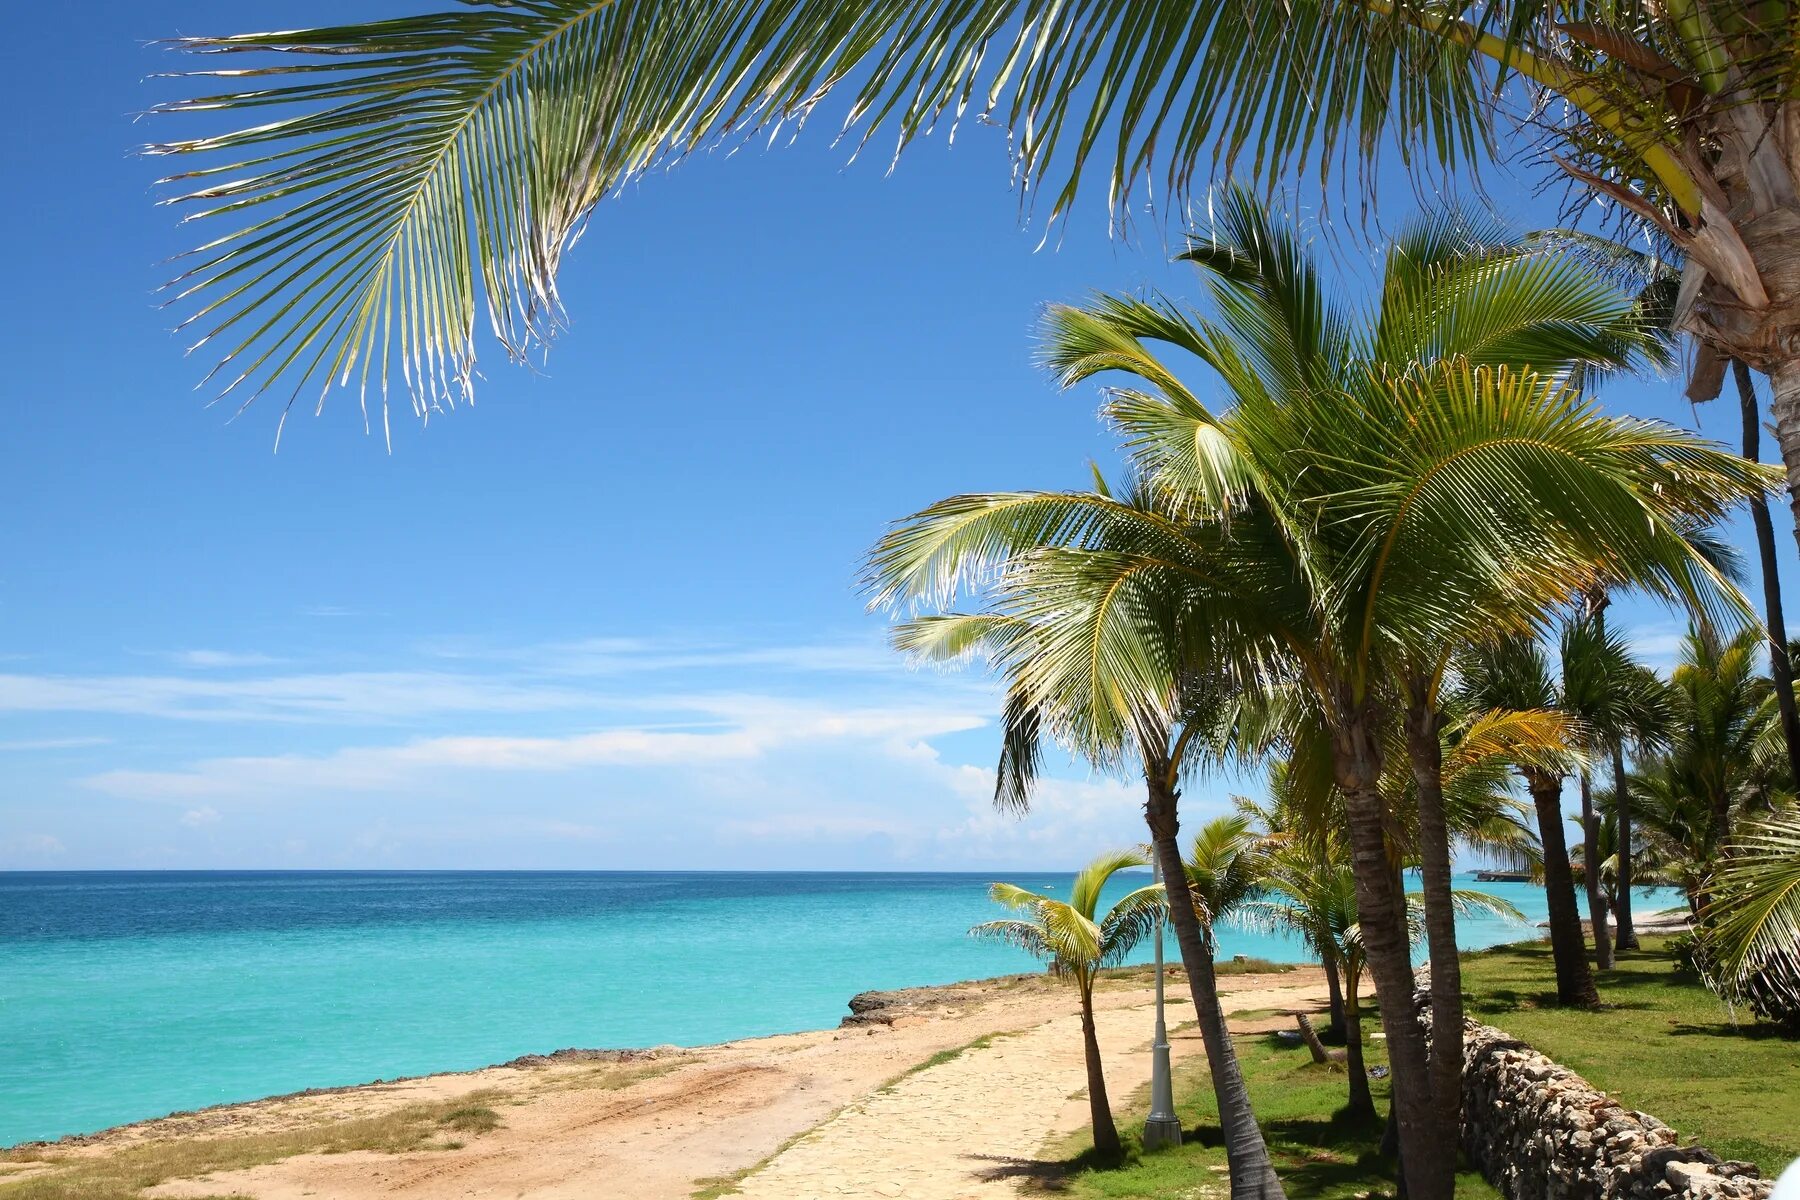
151;0;1490;426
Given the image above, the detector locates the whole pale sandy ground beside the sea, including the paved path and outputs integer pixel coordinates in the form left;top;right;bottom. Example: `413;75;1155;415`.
21;970;1325;1200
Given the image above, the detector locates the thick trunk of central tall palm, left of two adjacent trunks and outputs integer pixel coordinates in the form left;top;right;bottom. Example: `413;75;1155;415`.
1332;705;1456;1200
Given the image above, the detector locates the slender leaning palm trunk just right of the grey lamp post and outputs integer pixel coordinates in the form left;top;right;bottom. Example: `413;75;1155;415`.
1145;780;1287;1200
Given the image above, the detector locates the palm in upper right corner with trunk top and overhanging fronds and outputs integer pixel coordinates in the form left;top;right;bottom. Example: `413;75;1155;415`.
155;0;1800;504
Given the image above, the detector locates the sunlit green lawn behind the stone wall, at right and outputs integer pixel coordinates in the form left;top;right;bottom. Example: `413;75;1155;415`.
1462;937;1800;1175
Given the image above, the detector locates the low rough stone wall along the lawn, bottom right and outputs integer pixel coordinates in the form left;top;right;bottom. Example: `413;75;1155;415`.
1447;1009;1773;1200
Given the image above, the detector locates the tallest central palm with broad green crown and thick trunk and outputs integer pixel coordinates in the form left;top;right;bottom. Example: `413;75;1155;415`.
871;193;1768;1200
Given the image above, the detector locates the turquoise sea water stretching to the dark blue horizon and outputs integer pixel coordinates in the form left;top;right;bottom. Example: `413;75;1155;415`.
0;873;1674;1146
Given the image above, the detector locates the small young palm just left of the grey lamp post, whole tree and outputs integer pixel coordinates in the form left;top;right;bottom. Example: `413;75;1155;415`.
968;849;1163;1159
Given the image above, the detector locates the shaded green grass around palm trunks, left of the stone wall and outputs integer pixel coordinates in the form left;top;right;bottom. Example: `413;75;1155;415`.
1037;1022;1499;1200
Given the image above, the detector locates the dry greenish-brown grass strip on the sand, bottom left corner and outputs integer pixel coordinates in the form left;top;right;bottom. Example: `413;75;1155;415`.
0;1090;502;1200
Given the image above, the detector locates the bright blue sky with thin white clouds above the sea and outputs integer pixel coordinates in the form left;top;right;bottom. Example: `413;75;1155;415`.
0;0;1793;869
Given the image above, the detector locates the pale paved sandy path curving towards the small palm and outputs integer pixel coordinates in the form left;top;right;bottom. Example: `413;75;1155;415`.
727;986;1323;1200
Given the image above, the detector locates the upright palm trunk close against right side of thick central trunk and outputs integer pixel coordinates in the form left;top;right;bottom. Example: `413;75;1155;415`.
1404;689;1462;1144
